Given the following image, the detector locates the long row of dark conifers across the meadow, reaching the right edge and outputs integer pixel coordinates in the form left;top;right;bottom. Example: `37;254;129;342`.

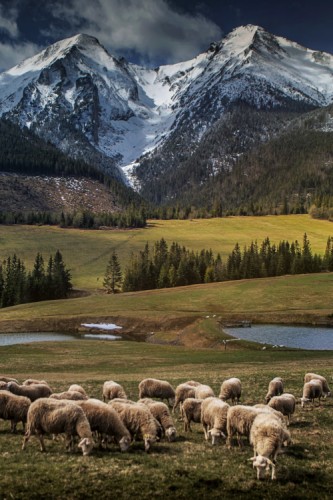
104;233;333;293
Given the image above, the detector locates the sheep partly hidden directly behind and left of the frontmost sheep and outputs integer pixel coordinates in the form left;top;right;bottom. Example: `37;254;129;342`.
227;405;269;448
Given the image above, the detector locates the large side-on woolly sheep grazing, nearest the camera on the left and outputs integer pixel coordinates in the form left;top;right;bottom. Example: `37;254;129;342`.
22;398;94;456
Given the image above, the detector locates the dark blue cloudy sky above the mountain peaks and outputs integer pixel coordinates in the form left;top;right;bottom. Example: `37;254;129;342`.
0;0;333;71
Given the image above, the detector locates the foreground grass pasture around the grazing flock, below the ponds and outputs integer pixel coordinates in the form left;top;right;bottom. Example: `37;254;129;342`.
0;341;333;500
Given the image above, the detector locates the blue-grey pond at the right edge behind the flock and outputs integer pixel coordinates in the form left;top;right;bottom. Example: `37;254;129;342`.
223;325;333;351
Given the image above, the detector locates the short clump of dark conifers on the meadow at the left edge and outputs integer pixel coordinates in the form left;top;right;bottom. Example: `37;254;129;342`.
0;250;72;307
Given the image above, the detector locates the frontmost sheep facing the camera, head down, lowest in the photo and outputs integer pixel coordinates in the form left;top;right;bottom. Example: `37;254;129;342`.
250;413;291;479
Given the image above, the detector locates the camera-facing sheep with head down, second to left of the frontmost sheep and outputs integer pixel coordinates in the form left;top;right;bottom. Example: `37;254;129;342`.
201;397;230;445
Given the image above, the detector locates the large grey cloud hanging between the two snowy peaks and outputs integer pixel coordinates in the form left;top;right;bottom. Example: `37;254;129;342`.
52;0;222;62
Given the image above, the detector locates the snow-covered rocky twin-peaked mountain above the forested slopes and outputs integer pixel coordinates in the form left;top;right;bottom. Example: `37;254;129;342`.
0;25;333;203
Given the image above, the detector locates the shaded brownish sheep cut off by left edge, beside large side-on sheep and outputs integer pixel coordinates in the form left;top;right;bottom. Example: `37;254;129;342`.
0;391;31;432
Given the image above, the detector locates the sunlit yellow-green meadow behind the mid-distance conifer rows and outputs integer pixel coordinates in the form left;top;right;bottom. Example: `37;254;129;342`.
0;215;333;290
